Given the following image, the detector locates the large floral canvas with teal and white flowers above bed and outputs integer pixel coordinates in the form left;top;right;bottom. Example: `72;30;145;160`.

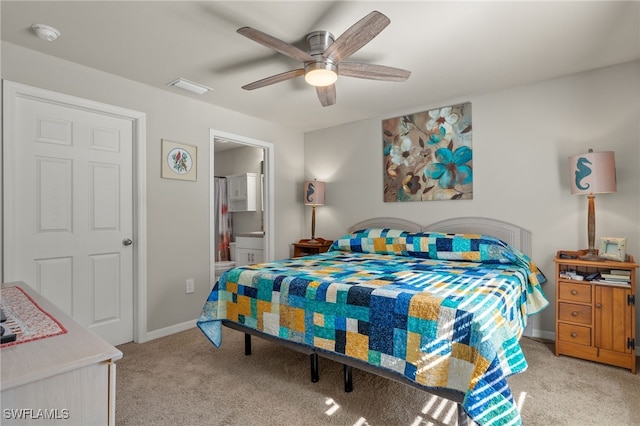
382;102;473;202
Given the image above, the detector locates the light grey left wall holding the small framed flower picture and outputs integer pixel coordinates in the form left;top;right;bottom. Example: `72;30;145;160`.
2;42;303;332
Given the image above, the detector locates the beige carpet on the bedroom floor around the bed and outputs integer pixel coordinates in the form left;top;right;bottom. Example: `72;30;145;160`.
116;328;640;426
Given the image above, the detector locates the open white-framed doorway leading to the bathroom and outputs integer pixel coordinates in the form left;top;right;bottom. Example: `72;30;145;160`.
209;129;275;288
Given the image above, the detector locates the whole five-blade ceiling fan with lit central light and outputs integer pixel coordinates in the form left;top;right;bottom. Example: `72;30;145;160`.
238;11;411;106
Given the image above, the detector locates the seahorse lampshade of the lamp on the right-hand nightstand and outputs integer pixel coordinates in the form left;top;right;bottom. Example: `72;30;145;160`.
569;151;617;194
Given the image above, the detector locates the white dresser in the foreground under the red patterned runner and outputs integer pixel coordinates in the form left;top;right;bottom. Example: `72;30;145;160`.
0;282;122;426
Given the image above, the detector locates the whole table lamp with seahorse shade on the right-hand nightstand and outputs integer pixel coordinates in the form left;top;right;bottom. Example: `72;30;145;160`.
569;149;616;261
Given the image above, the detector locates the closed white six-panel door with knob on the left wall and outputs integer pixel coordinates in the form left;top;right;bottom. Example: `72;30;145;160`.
3;81;133;345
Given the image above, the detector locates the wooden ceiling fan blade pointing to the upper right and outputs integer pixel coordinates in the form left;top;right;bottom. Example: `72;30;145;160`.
324;10;391;62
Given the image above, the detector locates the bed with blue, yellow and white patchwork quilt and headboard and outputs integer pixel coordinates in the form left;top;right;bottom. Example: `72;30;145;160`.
197;217;548;425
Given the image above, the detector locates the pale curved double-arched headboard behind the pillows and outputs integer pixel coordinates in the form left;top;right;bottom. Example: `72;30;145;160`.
347;217;533;256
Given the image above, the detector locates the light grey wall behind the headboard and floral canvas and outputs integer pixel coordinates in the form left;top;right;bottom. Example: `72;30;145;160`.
305;61;640;337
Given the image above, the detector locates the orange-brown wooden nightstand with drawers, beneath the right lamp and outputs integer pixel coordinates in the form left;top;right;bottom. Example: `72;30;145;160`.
554;250;638;374
